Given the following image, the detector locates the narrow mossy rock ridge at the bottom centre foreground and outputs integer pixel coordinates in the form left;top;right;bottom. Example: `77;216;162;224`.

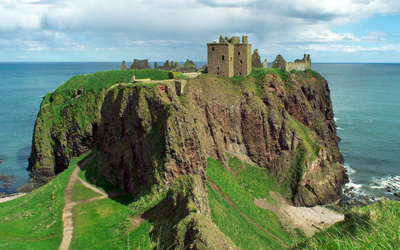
149;175;238;249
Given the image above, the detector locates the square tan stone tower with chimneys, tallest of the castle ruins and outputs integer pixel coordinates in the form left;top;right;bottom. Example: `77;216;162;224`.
207;36;251;77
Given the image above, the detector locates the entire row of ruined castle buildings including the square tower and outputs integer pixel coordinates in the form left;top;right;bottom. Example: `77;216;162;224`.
121;36;311;77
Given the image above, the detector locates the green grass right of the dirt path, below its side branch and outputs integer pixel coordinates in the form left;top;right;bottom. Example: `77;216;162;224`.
71;199;156;249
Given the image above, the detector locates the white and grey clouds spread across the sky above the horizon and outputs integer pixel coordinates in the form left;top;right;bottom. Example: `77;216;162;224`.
0;0;400;61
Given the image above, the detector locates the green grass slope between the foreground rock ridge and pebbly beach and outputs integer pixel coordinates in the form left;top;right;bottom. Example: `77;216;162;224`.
207;158;291;249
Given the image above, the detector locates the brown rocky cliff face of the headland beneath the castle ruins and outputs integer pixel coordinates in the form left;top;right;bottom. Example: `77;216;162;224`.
30;69;347;206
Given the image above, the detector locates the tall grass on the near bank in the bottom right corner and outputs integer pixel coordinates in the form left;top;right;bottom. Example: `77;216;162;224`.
294;200;400;250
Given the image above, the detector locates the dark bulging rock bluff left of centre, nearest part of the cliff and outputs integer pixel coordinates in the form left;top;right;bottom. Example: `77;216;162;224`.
98;85;206;193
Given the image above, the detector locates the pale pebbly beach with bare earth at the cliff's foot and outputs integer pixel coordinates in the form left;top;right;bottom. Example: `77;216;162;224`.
254;191;344;237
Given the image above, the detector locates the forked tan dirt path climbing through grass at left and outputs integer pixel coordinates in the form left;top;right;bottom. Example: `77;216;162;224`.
59;155;123;250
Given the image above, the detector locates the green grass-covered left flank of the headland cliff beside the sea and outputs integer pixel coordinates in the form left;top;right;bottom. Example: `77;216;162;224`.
24;70;168;190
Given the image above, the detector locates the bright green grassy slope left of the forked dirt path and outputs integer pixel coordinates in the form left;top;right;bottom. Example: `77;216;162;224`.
0;151;92;250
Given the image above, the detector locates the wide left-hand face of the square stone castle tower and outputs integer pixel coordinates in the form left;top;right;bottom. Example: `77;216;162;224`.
207;43;234;77
